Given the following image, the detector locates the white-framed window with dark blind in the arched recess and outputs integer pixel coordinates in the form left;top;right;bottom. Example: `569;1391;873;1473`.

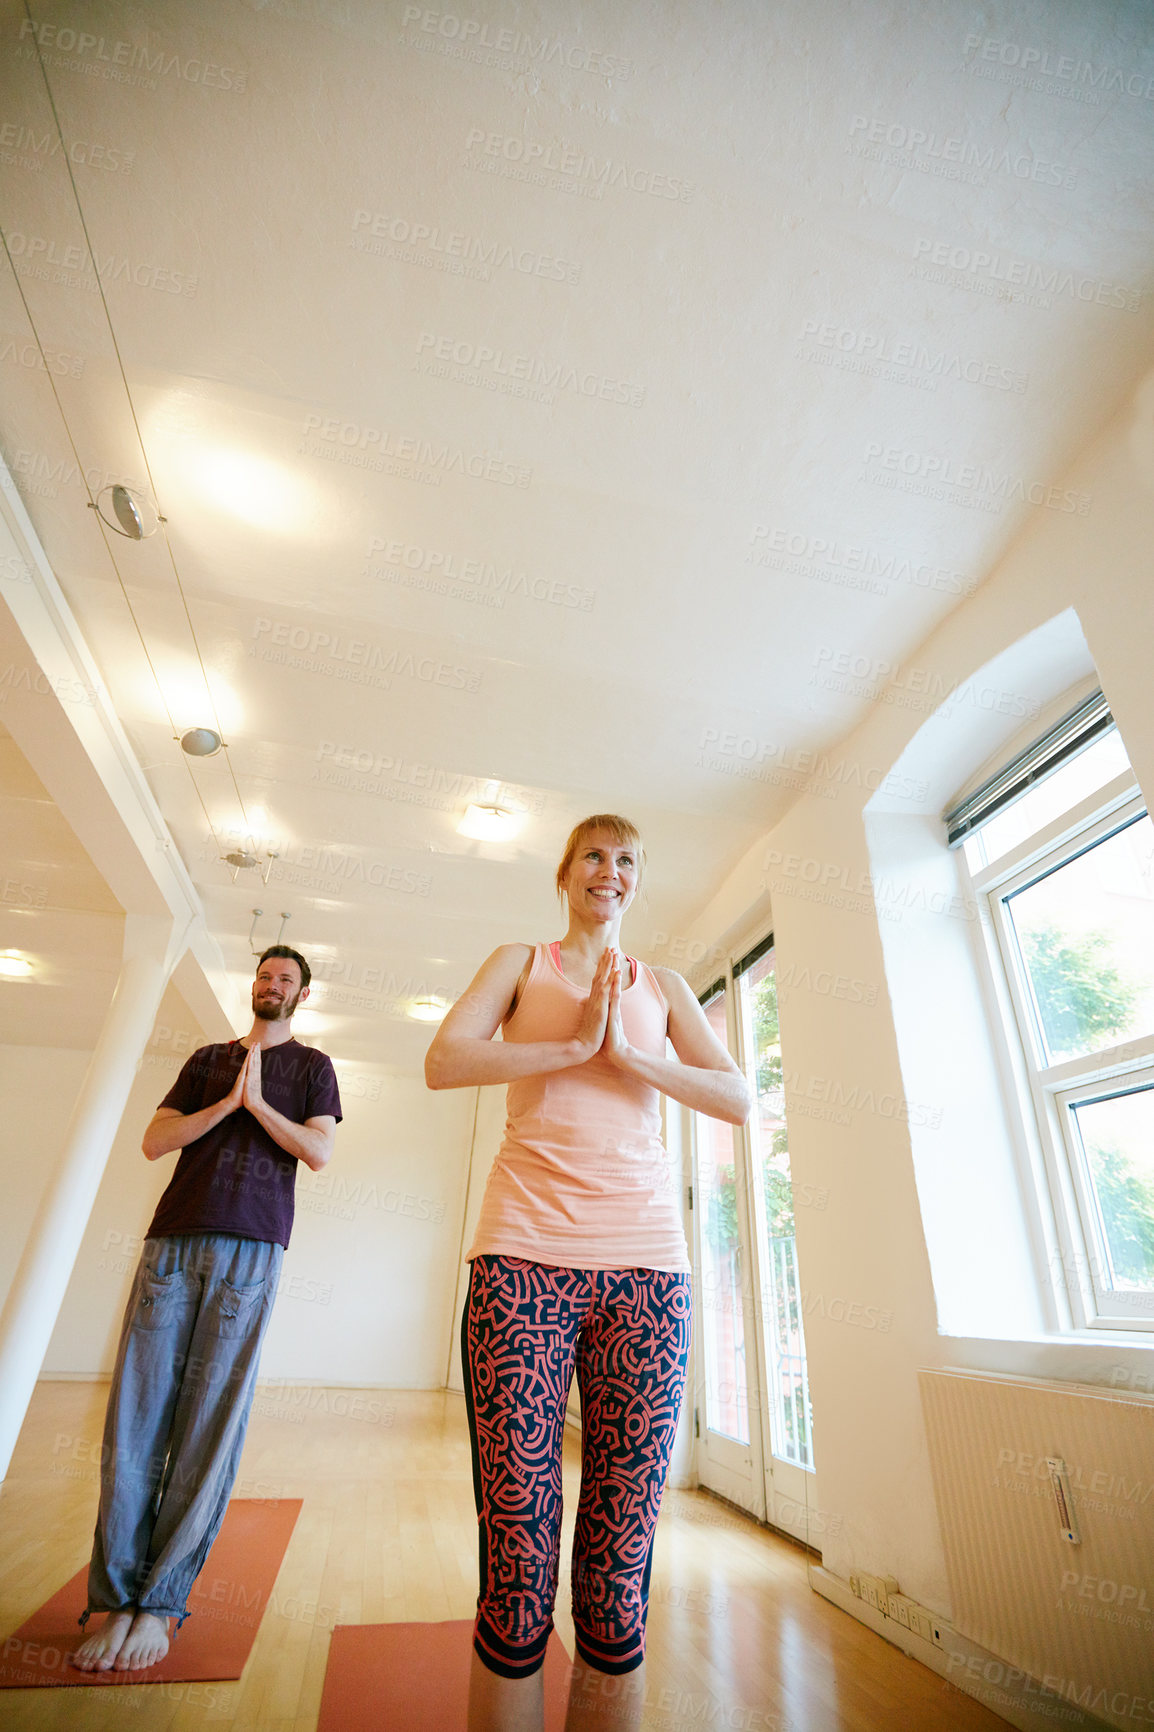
946;693;1154;1330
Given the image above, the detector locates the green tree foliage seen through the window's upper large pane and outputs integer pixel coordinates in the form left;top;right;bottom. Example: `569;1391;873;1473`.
1019;921;1138;1058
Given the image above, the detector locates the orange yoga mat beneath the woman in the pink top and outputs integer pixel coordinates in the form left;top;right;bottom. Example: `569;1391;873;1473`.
317;1619;570;1732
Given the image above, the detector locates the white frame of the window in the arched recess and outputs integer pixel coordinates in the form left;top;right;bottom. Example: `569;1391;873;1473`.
960;767;1154;1337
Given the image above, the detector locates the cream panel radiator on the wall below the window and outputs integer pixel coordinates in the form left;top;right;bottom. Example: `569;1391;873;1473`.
918;1372;1154;1729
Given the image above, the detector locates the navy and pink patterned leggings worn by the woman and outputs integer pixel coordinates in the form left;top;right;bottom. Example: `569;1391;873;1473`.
461;1257;691;1678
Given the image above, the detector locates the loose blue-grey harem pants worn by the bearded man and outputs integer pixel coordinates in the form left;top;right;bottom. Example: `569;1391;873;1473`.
80;1233;284;1625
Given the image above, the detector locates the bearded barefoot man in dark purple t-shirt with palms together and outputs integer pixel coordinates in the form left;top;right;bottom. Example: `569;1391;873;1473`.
71;944;341;1671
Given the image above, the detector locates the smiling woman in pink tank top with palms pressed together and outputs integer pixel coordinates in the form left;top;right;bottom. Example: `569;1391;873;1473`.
425;814;752;1732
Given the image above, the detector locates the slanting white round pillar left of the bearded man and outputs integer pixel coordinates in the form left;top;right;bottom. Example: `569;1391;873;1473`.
0;914;187;1479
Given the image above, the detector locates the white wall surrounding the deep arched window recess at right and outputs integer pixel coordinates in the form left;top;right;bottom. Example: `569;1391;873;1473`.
668;396;1154;1616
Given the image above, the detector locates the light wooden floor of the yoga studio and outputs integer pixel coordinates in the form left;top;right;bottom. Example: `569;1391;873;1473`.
0;1382;1005;1732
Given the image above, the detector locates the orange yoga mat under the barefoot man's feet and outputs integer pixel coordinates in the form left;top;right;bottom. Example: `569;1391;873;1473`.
0;1498;301;1690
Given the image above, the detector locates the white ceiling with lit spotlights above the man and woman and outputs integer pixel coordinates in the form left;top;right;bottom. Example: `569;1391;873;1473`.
0;0;1154;1067
